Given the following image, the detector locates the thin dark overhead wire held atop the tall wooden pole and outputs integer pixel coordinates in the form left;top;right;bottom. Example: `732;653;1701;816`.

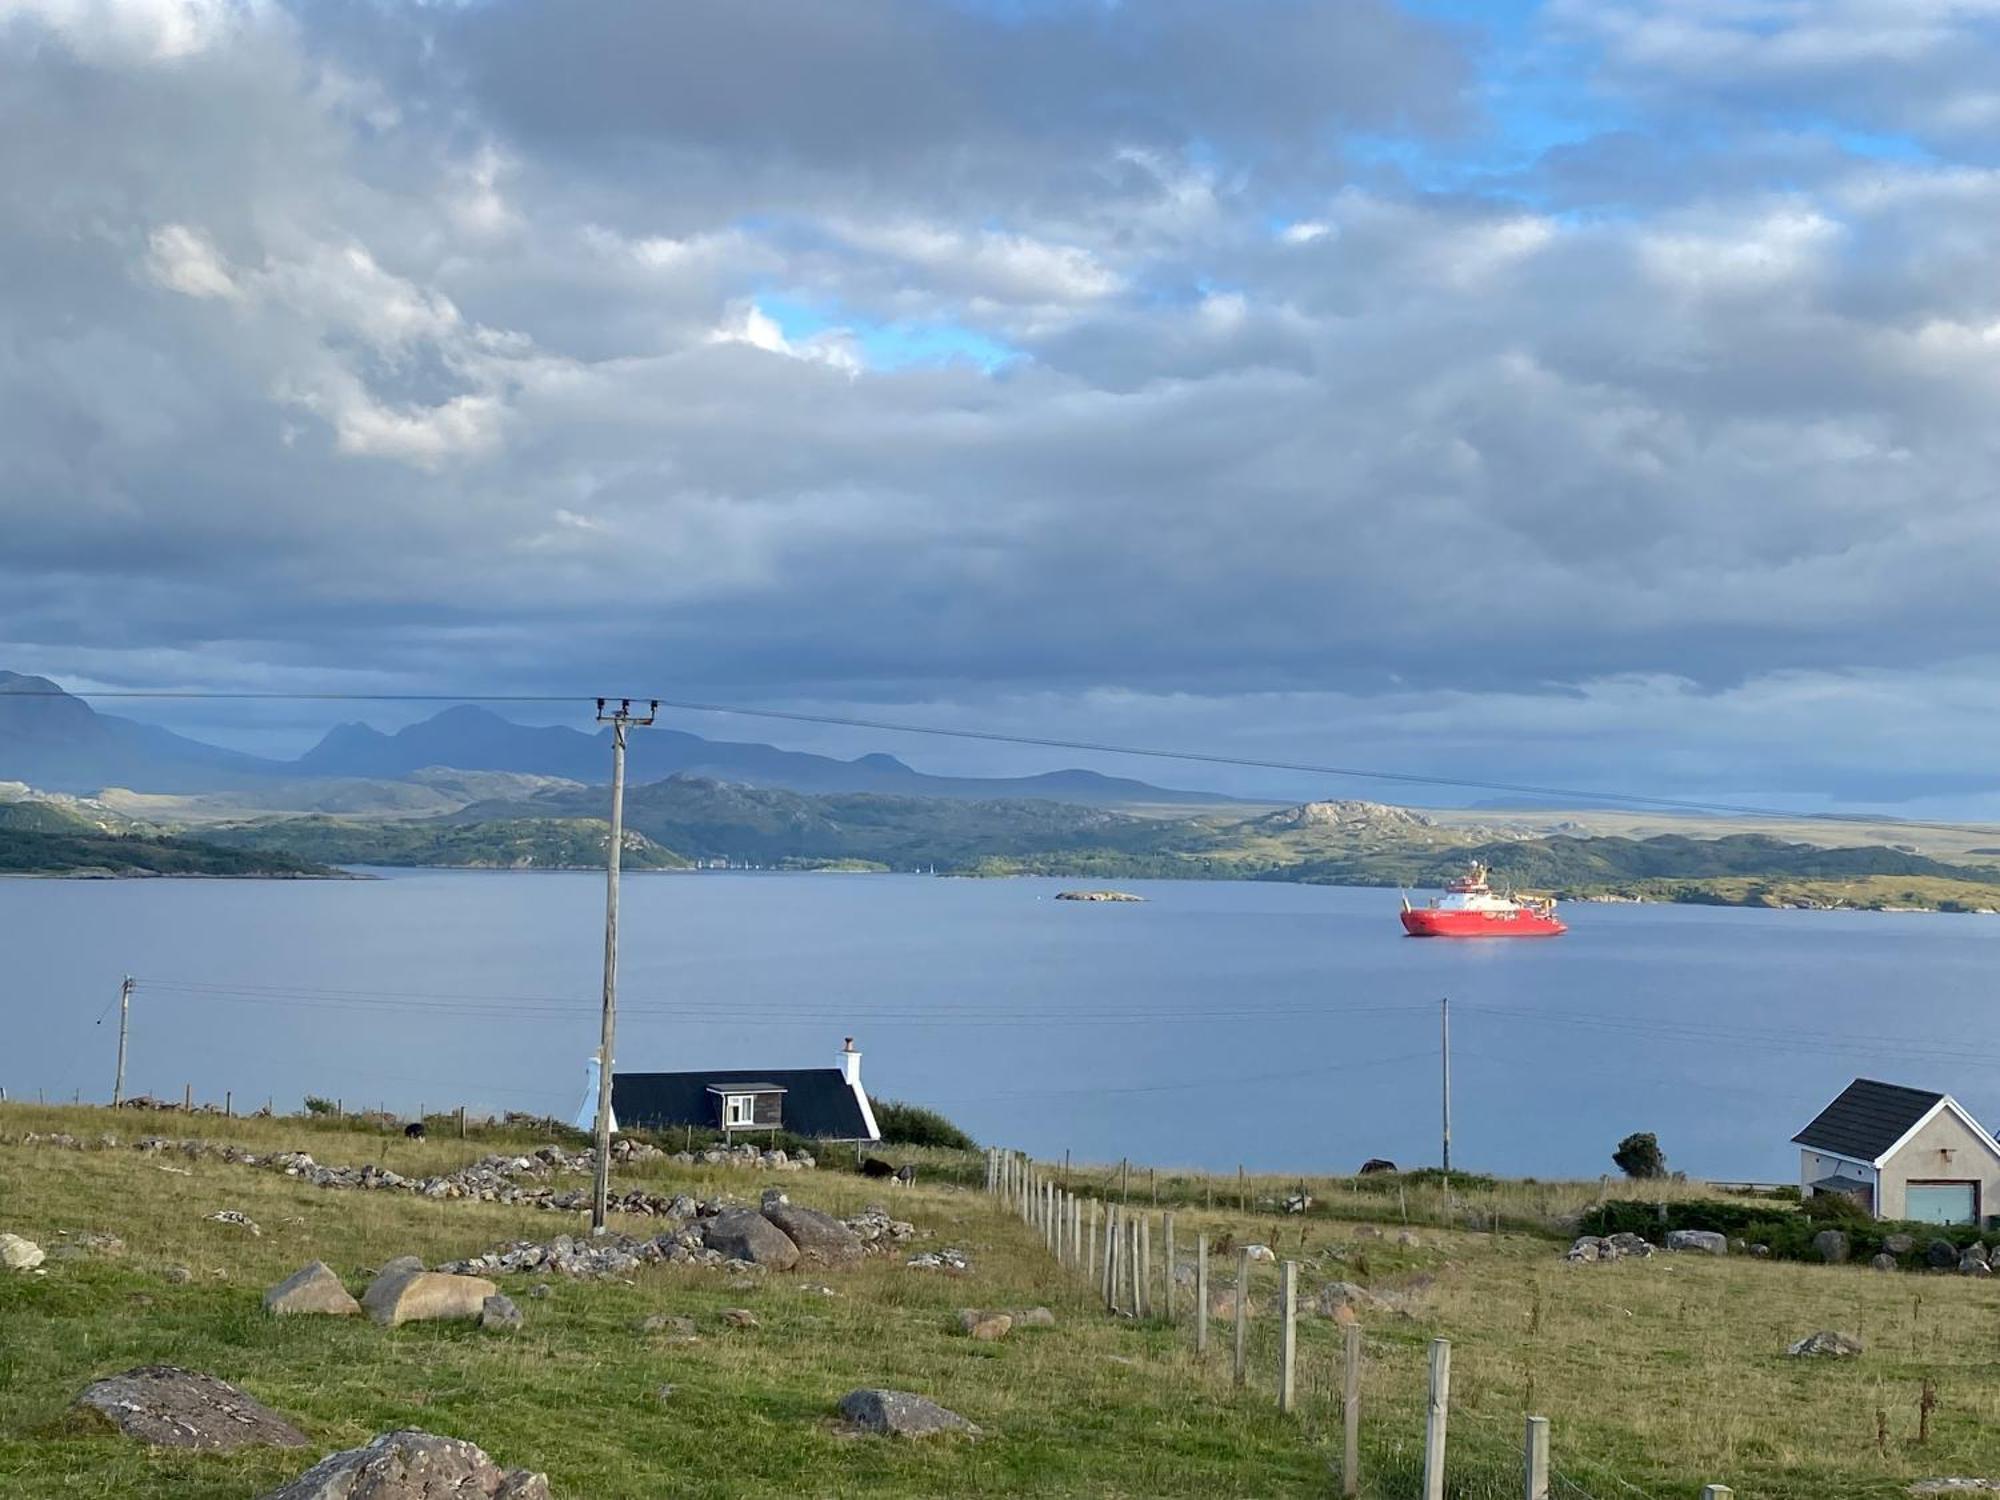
8;688;1996;834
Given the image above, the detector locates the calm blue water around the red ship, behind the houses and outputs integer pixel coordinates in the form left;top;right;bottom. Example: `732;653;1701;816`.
0;872;2000;1180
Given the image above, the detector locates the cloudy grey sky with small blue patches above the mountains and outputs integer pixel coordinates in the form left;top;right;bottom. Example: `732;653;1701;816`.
11;0;2000;816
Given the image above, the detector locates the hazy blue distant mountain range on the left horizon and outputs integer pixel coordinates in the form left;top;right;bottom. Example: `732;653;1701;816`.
0;672;1230;806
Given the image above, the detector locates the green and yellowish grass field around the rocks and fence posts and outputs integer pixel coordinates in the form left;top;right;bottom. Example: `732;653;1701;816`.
0;1104;2000;1500
